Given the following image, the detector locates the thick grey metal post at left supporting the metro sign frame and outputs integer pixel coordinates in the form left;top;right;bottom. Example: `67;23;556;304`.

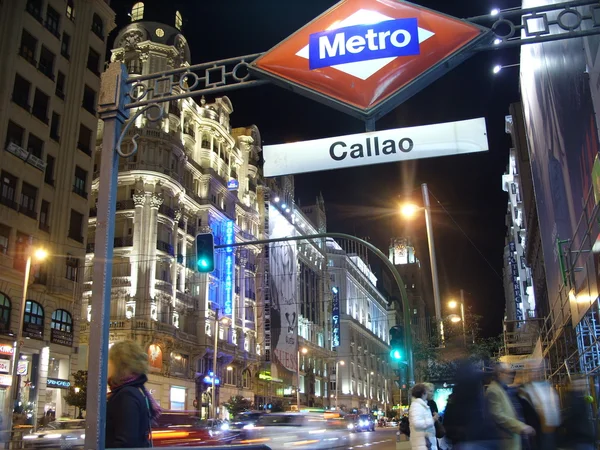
84;62;128;450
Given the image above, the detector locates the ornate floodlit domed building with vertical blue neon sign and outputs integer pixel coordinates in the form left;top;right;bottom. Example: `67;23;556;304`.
81;2;262;418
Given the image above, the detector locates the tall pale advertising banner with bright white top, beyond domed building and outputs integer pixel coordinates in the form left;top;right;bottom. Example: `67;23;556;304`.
269;208;298;372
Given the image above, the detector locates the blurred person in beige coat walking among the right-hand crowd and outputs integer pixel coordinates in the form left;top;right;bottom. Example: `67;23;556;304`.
486;364;535;450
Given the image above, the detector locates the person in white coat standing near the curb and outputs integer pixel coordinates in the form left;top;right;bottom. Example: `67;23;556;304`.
408;383;438;450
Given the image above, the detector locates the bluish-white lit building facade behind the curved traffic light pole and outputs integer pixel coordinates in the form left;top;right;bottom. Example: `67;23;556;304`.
327;240;396;412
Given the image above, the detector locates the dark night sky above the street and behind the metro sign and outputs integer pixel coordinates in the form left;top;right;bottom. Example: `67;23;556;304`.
112;0;520;335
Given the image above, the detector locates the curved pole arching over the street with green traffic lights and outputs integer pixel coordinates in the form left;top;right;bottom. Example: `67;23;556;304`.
215;233;415;386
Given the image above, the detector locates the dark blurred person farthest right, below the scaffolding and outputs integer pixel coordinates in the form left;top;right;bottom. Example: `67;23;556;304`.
561;378;596;450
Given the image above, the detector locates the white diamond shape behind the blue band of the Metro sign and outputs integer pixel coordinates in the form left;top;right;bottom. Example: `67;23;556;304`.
296;9;435;80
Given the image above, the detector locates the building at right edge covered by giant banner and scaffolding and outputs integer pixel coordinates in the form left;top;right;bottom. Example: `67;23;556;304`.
520;0;600;384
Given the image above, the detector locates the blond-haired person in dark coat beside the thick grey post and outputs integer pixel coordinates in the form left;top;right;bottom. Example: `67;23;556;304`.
106;341;160;448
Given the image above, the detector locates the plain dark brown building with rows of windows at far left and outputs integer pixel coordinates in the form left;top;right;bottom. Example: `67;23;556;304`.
0;0;115;425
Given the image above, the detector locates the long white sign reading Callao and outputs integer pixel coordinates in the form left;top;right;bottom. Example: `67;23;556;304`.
263;118;489;177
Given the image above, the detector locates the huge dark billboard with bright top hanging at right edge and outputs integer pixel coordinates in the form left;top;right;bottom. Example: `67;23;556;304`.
520;0;600;324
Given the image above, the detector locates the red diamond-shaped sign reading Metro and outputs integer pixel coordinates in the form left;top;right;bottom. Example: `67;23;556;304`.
252;0;491;119
